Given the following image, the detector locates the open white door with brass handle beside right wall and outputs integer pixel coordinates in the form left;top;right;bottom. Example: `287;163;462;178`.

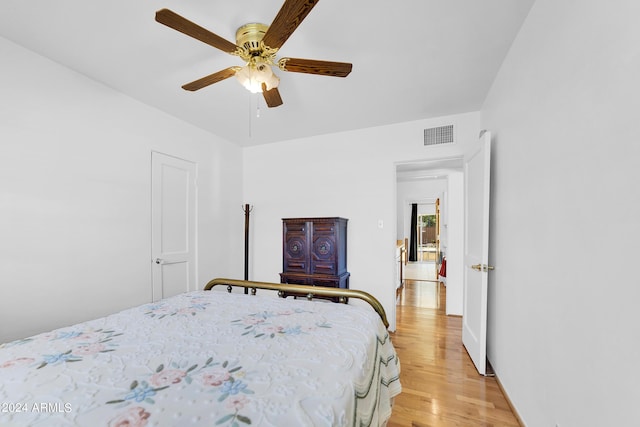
462;132;493;375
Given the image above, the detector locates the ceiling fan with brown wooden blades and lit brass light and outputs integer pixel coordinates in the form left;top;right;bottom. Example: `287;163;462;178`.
156;0;352;107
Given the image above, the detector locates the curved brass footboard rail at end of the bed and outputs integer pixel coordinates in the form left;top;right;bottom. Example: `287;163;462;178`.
204;278;389;328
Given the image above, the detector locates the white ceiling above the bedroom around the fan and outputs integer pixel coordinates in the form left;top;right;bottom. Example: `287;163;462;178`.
0;0;534;146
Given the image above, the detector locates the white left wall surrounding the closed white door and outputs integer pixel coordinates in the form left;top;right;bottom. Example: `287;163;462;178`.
0;38;243;342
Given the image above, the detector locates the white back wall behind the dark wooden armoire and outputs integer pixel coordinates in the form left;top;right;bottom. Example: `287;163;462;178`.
243;113;480;330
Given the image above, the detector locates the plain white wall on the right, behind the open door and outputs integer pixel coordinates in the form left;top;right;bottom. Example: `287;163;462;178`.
483;0;640;427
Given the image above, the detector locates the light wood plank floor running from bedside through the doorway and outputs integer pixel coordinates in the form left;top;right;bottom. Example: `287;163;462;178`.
388;280;520;427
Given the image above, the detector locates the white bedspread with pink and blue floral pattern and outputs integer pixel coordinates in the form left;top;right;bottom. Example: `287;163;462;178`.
0;291;401;427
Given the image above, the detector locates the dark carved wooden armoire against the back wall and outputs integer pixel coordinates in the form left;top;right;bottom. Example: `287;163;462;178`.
280;217;349;289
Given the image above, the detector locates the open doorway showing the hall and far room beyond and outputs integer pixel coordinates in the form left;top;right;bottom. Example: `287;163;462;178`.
396;158;463;315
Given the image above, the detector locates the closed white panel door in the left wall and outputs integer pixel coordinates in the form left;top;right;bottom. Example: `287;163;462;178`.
151;152;197;301
